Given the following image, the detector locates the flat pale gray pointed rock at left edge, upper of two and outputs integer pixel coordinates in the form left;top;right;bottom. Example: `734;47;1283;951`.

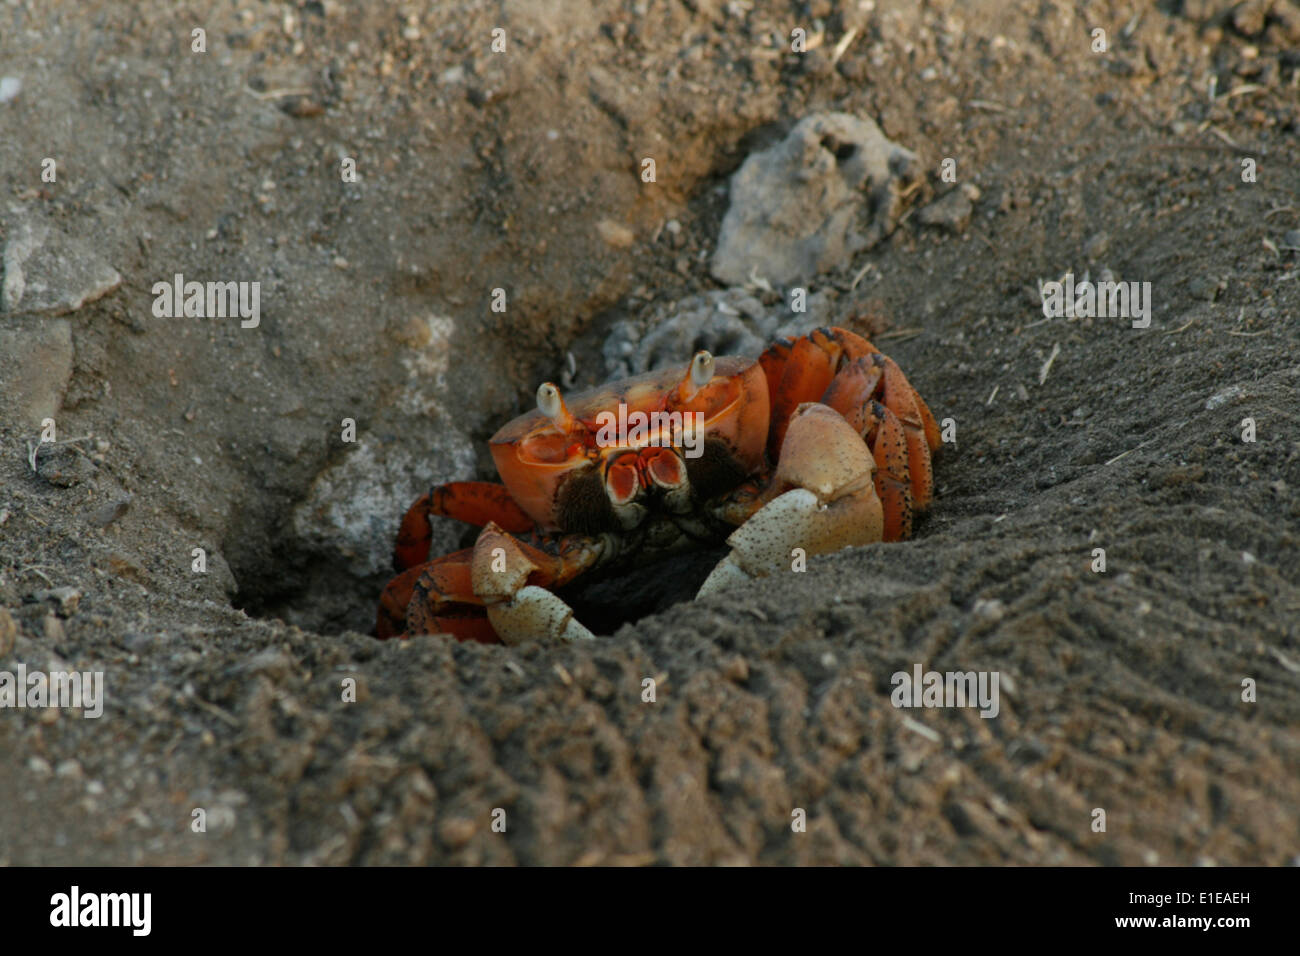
0;206;122;315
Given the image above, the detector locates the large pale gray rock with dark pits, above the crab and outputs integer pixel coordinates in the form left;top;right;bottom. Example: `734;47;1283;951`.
712;113;920;285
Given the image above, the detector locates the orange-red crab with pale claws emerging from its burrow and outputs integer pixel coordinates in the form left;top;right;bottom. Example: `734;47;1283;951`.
376;328;940;644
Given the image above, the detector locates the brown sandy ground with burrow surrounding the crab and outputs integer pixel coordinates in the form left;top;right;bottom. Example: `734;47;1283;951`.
0;0;1300;865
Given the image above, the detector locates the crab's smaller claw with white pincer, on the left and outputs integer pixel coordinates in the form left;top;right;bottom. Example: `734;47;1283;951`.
471;524;595;645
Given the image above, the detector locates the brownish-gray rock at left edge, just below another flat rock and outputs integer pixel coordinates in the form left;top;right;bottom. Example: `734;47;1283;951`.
0;319;73;428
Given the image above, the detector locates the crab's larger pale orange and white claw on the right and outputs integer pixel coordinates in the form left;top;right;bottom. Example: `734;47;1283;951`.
699;402;884;597
